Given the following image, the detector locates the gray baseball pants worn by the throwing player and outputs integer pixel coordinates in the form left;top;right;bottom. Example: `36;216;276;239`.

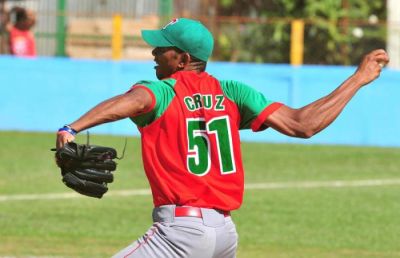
113;205;238;258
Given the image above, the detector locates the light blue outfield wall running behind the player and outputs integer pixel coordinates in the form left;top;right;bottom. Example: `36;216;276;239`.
0;56;400;146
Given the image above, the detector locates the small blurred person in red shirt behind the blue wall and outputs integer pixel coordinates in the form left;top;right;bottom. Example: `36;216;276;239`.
8;7;36;57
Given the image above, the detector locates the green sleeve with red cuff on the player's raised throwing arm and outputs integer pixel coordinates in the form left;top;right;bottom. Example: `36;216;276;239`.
220;80;282;131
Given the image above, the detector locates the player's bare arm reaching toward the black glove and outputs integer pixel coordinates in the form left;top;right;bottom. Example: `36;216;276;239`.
56;88;152;148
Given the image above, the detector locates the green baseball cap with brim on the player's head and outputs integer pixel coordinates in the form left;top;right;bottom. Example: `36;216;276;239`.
142;18;214;61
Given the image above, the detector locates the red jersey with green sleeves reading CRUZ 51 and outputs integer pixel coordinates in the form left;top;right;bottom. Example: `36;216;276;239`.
133;71;281;211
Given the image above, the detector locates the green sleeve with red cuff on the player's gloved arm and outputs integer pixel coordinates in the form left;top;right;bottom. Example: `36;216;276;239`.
131;79;176;127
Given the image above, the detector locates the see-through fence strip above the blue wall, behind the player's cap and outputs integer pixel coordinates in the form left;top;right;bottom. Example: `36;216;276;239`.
0;0;387;65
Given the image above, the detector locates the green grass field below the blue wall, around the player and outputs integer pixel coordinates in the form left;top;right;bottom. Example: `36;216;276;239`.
0;132;400;258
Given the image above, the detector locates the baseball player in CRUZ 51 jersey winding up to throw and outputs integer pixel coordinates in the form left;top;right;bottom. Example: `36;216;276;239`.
56;18;389;258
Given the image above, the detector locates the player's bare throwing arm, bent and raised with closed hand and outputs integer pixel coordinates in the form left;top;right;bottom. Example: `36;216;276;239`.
264;49;389;138
